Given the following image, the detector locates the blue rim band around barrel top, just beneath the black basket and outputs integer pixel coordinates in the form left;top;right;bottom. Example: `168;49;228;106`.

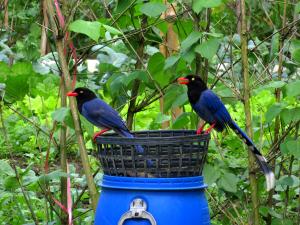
100;175;207;190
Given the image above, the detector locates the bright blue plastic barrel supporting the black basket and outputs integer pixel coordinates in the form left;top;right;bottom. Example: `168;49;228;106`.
95;175;210;225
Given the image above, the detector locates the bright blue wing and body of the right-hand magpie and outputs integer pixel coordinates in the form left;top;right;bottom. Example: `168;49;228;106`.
193;89;231;130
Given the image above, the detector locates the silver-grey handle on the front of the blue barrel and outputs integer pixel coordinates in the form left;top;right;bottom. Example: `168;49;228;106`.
118;198;156;225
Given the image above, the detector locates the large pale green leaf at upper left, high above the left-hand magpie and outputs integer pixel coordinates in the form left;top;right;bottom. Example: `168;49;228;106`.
69;20;101;42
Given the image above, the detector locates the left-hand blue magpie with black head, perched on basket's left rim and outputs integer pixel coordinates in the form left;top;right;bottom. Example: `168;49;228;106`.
67;87;144;153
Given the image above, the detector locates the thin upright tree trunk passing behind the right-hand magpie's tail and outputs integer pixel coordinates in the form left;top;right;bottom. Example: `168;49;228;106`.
240;0;259;225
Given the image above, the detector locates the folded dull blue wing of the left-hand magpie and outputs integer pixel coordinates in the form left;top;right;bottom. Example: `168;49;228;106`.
82;98;129;132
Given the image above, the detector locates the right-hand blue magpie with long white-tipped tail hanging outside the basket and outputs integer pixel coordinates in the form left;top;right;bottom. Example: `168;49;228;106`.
178;75;275;191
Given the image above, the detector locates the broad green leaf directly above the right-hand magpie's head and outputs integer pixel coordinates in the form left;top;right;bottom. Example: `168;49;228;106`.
195;38;220;60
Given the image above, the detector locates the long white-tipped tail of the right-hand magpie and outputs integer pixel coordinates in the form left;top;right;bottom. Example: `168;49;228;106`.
228;121;275;191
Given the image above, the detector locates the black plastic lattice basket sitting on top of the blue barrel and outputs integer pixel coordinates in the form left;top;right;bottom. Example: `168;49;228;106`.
97;130;210;177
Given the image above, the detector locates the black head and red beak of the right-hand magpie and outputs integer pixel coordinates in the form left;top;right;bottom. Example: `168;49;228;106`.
177;74;207;104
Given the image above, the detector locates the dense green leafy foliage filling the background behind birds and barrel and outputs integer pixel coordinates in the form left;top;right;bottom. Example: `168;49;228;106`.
0;0;300;225
